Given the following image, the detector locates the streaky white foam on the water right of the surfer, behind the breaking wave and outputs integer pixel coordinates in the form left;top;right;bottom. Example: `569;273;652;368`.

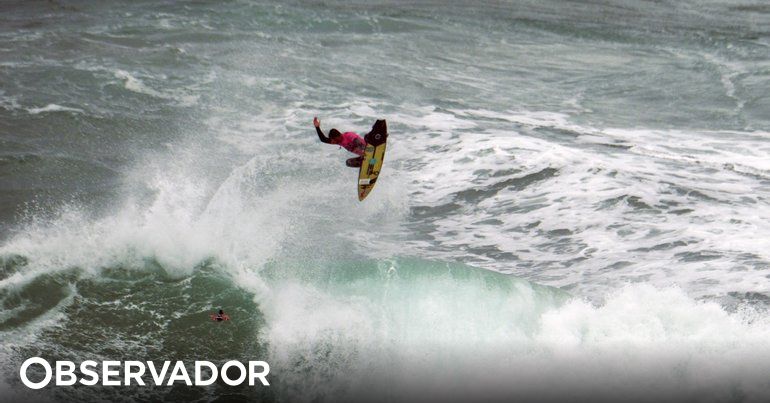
380;110;770;298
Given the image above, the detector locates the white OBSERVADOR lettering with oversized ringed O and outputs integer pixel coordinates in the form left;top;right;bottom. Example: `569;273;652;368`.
19;357;270;389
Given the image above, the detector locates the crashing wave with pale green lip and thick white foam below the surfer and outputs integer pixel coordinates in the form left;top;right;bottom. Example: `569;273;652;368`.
258;266;770;400
